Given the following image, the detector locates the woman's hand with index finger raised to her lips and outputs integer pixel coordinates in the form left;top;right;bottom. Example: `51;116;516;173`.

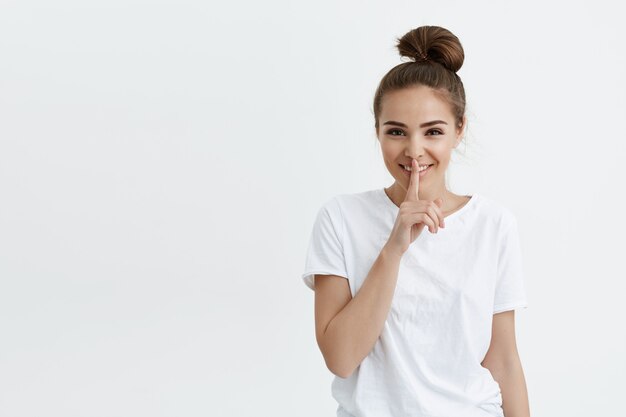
385;159;445;256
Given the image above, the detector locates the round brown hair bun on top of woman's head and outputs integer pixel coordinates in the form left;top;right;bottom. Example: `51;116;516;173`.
396;26;465;73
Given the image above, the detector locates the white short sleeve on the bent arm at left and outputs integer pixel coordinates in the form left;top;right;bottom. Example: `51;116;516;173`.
302;198;348;290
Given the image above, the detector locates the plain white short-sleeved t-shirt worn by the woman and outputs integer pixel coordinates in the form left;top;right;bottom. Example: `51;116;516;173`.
302;188;527;417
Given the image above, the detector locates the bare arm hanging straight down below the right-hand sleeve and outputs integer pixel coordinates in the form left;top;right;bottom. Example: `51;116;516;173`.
481;310;530;417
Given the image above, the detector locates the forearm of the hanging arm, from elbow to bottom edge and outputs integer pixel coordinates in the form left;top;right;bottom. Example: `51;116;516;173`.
489;358;530;417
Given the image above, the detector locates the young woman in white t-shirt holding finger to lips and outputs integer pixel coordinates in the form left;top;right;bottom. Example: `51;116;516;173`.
302;26;530;417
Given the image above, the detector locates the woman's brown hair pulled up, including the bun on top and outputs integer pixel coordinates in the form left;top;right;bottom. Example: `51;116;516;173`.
374;26;465;138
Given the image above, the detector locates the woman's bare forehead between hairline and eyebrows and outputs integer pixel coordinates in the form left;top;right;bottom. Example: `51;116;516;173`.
380;86;453;125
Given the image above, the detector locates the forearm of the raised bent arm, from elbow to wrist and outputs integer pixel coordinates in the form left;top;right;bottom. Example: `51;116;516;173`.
324;244;401;378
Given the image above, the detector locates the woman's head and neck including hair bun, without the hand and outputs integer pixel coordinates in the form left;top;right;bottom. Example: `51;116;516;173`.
374;26;468;213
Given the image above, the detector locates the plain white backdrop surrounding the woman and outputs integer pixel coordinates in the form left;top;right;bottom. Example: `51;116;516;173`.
0;0;626;417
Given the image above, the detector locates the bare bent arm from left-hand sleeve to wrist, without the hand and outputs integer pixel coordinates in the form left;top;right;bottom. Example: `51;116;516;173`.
315;247;401;378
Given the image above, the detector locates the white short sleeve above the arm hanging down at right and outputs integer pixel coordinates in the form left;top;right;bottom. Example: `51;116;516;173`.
493;213;528;314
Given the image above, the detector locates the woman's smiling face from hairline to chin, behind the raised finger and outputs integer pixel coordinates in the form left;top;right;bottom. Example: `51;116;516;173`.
377;86;465;199
